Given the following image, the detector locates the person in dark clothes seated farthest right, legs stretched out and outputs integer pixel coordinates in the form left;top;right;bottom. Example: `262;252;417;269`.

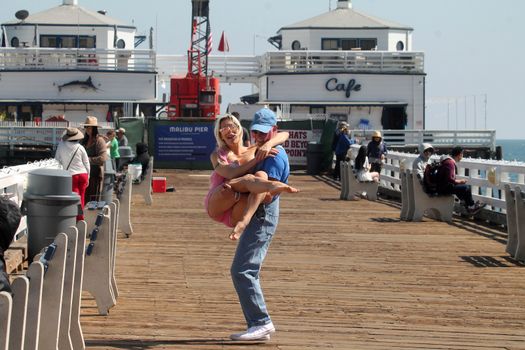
437;146;486;214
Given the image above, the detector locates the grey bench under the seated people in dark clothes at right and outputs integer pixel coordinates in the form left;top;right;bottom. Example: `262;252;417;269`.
405;169;454;222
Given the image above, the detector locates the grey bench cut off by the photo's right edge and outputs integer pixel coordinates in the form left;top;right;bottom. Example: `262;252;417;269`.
505;184;525;261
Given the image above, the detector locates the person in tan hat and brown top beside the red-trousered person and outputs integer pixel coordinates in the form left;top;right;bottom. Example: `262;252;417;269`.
81;116;108;202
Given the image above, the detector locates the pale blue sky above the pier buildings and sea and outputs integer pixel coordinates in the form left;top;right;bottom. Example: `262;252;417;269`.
0;0;525;139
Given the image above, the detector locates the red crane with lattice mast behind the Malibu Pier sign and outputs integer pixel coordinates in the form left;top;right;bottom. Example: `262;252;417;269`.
168;0;220;119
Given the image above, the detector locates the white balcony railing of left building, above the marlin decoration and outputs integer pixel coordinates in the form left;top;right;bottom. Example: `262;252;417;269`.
0;47;156;72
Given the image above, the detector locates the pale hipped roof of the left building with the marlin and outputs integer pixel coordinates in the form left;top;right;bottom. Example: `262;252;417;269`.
3;5;134;28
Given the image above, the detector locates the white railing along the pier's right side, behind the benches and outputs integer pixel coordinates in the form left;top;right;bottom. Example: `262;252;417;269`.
381;152;525;213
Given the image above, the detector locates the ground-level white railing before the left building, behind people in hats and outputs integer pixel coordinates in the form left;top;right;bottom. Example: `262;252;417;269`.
0;122;114;148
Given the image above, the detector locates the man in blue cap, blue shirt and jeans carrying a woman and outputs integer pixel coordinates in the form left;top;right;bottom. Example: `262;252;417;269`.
230;108;290;341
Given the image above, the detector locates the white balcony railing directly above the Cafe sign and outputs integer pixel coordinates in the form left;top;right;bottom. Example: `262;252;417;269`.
262;50;424;74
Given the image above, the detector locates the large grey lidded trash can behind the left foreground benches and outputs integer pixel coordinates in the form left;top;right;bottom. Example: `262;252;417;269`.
24;169;80;262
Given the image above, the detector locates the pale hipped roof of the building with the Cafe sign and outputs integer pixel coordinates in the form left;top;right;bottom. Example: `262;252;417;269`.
278;8;413;32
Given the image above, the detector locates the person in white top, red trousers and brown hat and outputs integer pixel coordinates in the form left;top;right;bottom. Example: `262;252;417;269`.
55;128;90;221
